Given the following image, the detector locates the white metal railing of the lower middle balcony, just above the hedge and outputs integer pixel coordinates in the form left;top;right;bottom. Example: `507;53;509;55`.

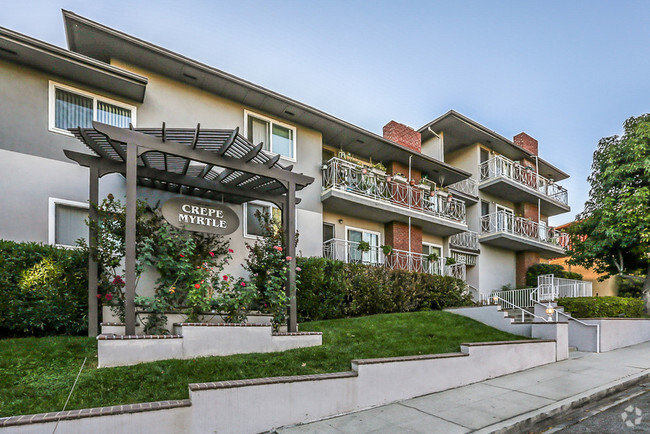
323;238;466;281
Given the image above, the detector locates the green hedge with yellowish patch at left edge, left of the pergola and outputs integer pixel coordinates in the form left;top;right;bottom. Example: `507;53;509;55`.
0;240;88;336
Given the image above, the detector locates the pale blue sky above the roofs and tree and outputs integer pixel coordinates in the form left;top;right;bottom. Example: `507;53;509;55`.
0;0;650;225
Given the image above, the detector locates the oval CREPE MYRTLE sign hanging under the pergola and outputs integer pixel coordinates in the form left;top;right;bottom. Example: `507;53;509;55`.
162;196;239;235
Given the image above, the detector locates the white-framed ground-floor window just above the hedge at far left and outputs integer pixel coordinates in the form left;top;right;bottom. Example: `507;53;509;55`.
48;197;88;247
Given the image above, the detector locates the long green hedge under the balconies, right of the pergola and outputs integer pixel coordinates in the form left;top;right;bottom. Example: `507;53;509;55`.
298;257;472;321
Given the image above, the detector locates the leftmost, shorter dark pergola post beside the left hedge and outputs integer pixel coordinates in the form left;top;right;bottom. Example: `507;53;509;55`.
88;165;99;337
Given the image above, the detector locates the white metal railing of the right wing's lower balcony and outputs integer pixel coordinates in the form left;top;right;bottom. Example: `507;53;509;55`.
481;211;569;248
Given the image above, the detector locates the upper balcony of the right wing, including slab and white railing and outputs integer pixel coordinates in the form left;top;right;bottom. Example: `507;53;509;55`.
479;155;571;216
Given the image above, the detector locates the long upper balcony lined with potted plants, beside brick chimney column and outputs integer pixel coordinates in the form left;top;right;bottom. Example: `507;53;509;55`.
321;158;467;236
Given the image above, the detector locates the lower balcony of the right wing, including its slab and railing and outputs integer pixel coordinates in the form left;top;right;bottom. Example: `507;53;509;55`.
479;211;569;258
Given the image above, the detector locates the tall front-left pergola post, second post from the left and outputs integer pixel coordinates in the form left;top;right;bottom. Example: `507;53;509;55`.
124;142;138;335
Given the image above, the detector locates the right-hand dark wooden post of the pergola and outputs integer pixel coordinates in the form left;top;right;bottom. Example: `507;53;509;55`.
283;182;298;333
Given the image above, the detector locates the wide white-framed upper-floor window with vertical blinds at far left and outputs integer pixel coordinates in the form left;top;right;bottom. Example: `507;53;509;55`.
48;81;136;135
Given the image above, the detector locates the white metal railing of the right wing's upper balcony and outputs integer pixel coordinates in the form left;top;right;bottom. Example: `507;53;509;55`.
479;155;569;205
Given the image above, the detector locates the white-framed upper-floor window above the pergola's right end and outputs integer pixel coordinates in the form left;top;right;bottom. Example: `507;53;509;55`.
244;110;296;161
